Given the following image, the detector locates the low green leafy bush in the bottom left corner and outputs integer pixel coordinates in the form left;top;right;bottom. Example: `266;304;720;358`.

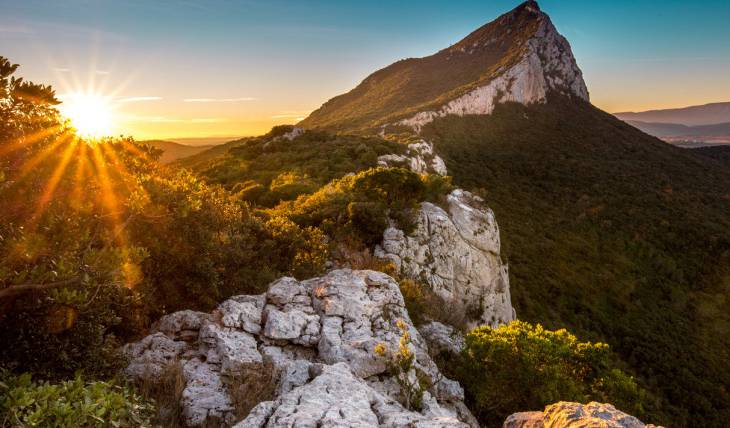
0;372;154;427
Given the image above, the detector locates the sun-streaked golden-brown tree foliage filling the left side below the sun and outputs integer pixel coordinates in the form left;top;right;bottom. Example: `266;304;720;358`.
0;59;327;378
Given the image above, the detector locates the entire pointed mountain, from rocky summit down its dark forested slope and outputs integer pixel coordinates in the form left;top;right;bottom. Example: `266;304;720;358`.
300;1;730;427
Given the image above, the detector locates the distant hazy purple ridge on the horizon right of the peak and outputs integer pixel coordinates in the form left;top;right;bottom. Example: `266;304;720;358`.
614;102;730;126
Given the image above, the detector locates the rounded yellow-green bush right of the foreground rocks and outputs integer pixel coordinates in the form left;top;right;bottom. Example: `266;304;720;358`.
456;321;643;426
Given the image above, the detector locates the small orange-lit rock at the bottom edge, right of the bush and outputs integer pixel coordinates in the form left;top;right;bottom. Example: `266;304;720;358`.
502;401;657;428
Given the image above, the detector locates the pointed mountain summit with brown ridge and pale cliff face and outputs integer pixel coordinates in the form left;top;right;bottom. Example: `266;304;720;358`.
299;1;589;131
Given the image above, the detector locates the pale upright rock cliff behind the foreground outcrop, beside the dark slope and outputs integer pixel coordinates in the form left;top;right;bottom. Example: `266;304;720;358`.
375;189;515;327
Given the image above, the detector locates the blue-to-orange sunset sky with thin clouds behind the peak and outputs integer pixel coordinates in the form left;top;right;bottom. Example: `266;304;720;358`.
0;0;730;139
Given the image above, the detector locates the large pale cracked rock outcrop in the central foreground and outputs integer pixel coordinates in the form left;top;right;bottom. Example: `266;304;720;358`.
124;270;476;427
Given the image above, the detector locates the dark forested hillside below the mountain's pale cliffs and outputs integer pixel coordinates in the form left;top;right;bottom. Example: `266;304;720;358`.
423;97;730;426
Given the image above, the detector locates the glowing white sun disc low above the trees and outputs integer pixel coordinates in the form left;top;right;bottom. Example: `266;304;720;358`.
59;93;113;138
